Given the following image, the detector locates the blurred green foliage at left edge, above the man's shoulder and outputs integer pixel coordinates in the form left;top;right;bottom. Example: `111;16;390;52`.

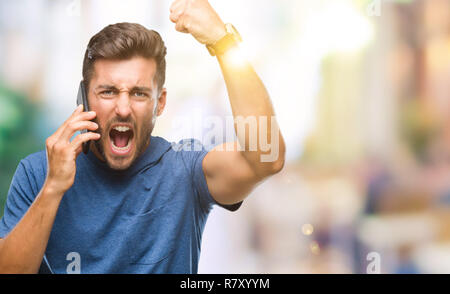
0;82;41;216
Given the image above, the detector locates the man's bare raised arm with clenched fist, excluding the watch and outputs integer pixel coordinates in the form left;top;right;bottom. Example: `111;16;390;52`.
170;0;285;204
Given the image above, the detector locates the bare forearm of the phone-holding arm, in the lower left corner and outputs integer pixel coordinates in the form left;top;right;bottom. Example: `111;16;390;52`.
0;184;62;273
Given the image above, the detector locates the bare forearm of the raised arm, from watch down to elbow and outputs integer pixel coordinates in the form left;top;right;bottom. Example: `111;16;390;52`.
217;53;285;174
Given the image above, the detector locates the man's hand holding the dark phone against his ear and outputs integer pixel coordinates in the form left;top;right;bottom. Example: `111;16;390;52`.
45;105;100;195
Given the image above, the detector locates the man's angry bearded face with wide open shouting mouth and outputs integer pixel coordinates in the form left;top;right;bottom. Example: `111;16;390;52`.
88;57;167;170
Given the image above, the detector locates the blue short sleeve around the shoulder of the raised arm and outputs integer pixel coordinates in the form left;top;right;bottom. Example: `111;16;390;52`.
177;139;242;212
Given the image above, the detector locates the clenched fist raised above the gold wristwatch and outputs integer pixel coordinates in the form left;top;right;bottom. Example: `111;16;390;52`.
170;0;226;45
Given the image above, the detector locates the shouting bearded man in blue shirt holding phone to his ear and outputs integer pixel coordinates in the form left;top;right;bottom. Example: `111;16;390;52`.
0;0;285;273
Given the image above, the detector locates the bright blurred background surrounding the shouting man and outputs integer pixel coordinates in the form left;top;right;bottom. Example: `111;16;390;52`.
0;0;450;273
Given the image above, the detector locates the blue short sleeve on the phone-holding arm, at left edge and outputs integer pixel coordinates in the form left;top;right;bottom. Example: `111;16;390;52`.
0;160;36;238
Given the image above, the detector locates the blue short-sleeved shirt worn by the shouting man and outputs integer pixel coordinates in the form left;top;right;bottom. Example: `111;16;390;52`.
0;136;241;273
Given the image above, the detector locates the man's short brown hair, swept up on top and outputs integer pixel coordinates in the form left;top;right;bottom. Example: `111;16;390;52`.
83;22;167;90
